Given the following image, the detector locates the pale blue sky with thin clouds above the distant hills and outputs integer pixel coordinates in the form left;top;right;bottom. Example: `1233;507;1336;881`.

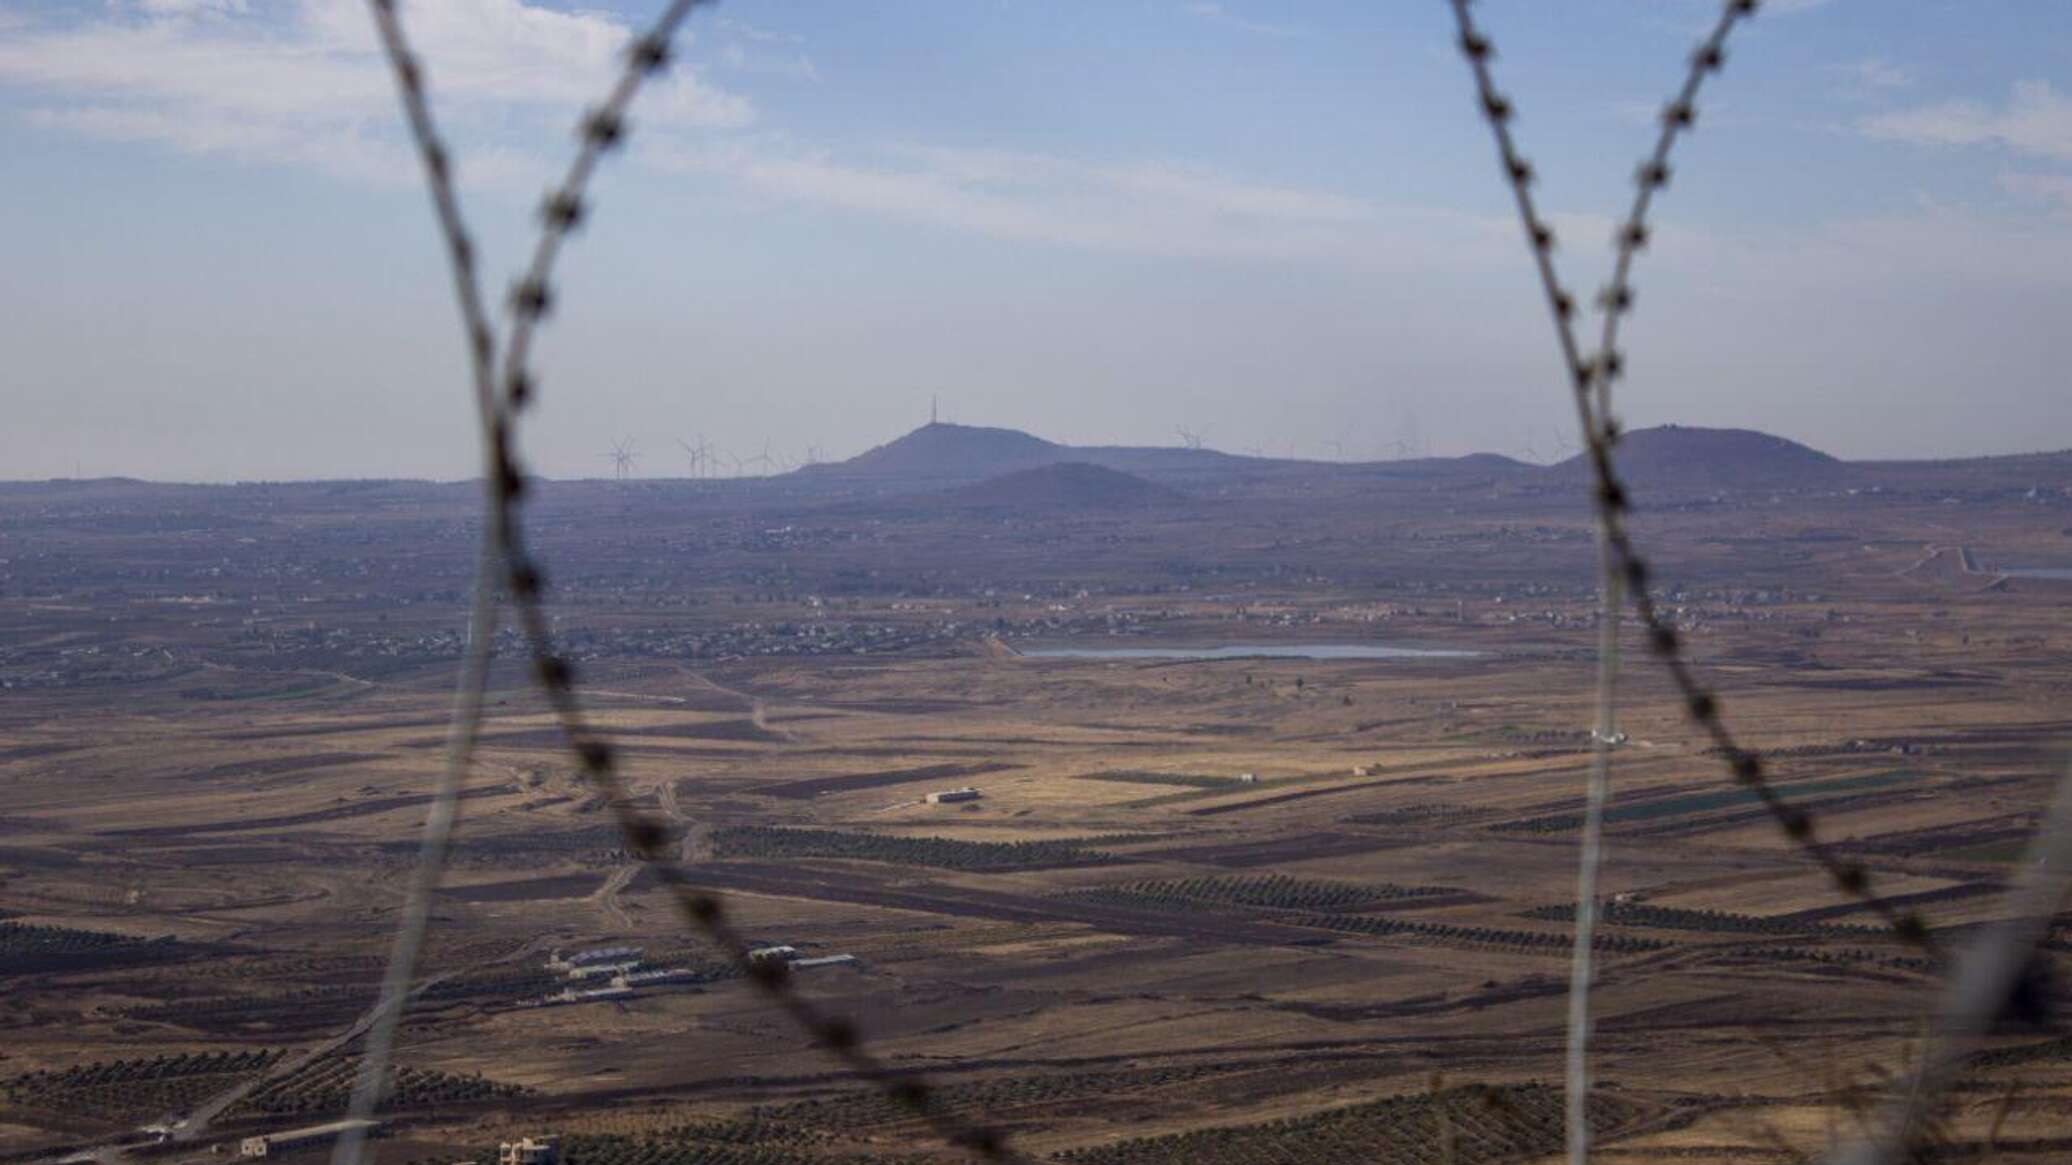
0;0;2072;481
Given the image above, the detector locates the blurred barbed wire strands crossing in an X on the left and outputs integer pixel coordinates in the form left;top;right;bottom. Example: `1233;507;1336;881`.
360;0;1028;1165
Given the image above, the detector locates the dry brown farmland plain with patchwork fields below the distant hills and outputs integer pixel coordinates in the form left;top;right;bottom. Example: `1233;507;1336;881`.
0;420;2072;1165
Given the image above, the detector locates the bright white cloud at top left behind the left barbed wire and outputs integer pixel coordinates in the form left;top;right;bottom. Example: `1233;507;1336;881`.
0;0;752;180
